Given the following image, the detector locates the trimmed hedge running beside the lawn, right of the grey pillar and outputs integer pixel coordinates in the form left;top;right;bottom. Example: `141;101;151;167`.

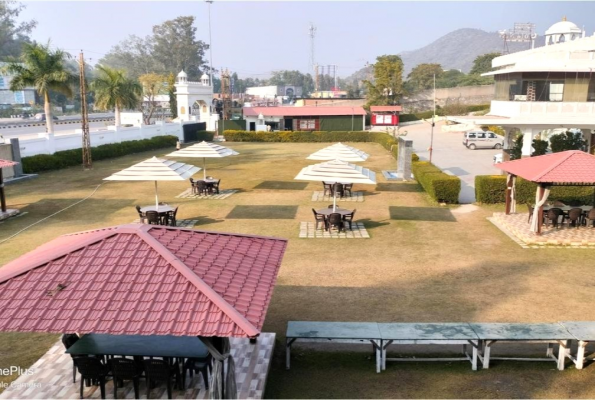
411;161;461;204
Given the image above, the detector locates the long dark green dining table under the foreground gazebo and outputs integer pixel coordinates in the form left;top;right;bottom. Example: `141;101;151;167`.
66;333;209;359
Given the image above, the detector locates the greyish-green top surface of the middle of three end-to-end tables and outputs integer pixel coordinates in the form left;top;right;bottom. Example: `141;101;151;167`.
378;322;477;340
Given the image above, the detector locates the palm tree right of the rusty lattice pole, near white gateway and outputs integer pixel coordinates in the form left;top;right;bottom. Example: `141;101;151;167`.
91;65;143;126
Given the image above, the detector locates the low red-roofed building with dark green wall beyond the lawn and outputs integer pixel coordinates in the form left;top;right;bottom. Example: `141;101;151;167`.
243;106;366;131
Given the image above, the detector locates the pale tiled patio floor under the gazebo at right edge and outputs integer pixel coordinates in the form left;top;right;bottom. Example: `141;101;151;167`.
490;213;595;248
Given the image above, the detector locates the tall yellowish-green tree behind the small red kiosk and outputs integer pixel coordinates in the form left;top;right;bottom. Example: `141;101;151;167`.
363;55;403;106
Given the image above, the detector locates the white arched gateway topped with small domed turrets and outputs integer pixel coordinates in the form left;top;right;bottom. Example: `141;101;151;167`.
174;71;219;131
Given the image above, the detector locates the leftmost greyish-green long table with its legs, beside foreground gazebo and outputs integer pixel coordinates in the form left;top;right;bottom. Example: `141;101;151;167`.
285;321;382;373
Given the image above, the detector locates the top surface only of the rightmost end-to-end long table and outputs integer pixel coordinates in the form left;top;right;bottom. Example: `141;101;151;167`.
469;322;573;340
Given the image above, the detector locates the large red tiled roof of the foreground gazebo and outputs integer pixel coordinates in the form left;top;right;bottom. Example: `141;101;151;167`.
0;224;287;337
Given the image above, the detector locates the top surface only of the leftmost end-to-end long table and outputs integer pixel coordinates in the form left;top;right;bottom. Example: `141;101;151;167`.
285;321;380;340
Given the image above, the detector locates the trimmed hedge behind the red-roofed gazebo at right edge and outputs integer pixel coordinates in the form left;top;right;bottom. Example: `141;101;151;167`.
475;175;594;204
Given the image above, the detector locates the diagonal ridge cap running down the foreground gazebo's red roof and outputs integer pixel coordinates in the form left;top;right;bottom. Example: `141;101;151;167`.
136;227;260;337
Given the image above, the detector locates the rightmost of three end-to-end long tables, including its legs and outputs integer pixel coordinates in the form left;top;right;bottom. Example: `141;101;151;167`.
469;323;573;370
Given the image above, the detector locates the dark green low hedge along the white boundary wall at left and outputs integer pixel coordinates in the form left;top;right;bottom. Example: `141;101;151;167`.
21;136;178;174
